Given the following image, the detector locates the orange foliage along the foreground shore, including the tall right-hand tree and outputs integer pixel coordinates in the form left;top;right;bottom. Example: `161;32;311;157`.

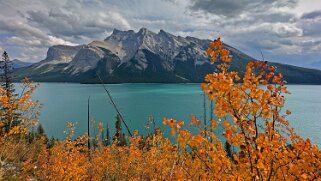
1;39;321;180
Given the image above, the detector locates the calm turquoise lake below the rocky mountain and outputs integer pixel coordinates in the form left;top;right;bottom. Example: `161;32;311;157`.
16;83;321;146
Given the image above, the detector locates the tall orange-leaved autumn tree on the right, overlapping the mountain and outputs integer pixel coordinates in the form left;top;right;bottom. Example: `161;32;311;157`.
202;38;320;180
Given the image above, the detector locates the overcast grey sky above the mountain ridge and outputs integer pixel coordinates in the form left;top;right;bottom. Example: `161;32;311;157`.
0;0;321;69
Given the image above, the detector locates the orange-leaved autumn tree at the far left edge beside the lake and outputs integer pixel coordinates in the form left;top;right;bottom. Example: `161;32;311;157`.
0;79;40;180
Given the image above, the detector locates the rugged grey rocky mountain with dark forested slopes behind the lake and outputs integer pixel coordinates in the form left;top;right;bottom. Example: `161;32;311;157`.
14;28;321;84
